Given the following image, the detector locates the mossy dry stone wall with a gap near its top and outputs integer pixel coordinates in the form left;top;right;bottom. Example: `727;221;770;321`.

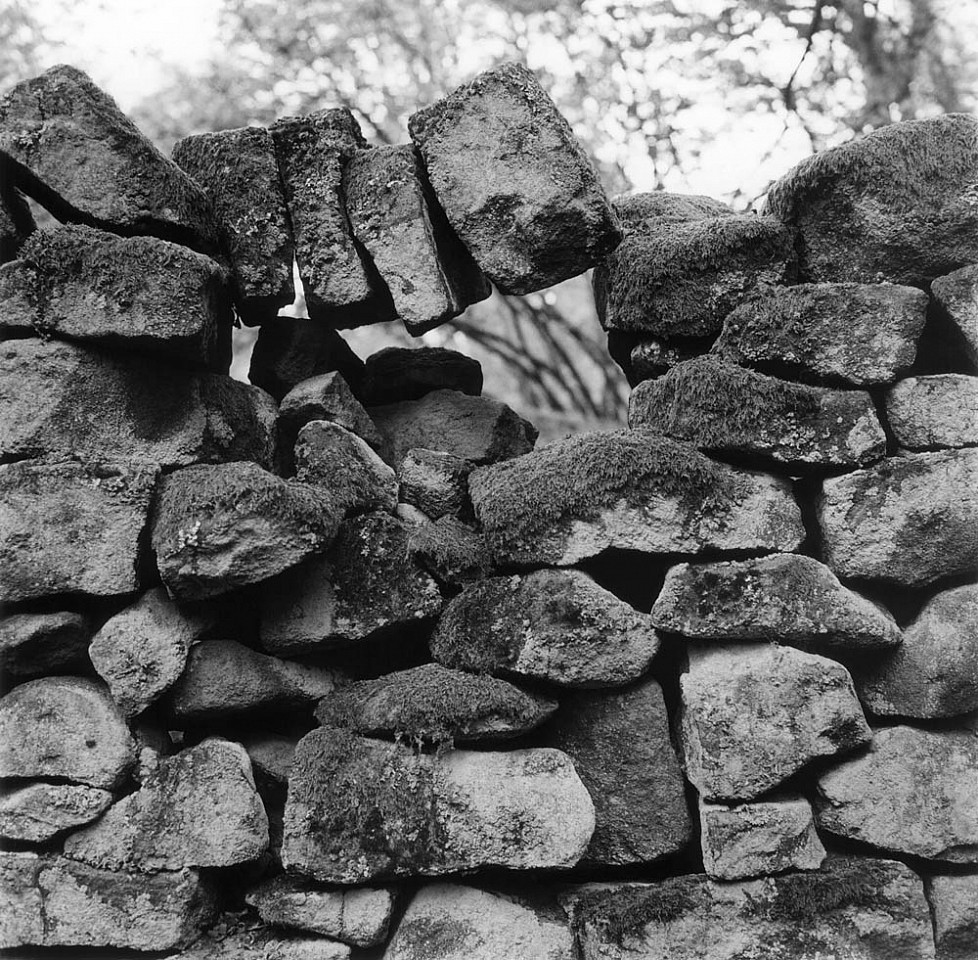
0;58;978;960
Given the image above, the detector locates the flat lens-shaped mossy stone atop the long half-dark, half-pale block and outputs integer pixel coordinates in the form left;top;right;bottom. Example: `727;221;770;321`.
316;663;557;743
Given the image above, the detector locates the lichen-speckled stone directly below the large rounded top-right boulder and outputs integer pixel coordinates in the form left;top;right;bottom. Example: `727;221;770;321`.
711;283;927;386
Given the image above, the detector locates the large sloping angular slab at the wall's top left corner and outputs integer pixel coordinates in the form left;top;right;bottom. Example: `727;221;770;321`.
0;64;218;252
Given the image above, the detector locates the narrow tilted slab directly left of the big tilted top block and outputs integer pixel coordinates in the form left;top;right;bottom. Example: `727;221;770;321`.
343;144;492;336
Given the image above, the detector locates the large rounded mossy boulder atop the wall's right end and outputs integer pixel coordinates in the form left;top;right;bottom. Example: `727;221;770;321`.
767;113;978;286
